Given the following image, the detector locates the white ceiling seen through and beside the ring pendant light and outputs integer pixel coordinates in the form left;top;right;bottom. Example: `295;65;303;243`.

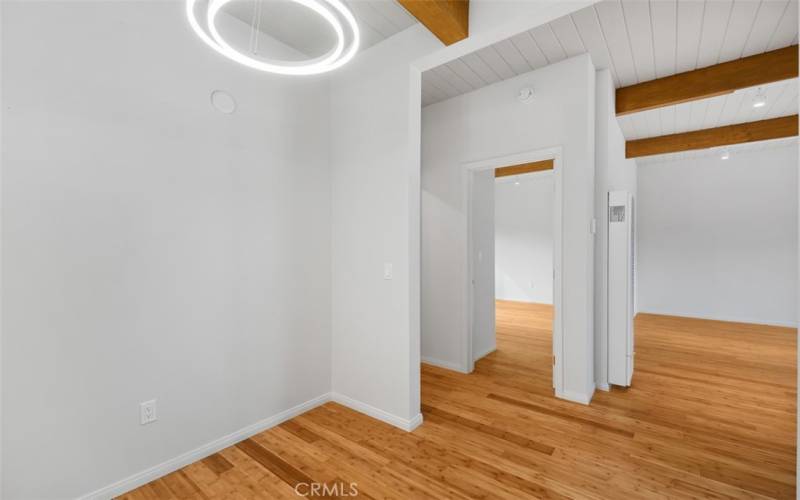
225;0;417;57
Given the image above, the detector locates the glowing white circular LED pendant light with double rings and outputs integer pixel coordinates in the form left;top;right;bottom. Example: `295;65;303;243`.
186;0;361;75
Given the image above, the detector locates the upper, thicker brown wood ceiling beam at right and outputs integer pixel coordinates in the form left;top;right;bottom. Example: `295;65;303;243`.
617;45;798;115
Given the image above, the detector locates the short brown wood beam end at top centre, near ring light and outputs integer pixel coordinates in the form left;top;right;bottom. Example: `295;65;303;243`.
398;0;469;45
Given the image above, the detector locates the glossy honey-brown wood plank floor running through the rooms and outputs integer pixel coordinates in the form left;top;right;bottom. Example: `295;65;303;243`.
124;302;796;499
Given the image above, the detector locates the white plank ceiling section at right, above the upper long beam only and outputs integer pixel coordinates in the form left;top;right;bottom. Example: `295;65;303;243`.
422;0;798;118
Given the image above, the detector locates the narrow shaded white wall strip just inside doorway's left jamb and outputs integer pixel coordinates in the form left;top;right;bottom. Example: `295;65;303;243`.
468;169;496;371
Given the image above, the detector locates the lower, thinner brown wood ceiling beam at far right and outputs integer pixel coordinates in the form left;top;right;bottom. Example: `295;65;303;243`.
625;115;797;158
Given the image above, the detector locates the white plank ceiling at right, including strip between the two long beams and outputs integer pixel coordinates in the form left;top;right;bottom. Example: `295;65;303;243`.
422;0;798;152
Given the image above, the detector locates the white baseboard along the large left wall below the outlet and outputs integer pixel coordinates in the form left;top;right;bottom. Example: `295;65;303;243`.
80;393;331;500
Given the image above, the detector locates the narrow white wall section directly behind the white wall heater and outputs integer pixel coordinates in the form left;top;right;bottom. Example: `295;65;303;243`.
594;69;638;390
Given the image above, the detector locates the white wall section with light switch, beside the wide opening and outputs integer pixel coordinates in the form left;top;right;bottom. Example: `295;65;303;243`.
330;25;440;426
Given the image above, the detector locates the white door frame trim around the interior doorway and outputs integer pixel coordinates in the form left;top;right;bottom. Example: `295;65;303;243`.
461;146;564;393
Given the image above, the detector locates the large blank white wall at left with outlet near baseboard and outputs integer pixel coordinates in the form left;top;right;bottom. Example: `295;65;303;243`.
1;1;331;500
